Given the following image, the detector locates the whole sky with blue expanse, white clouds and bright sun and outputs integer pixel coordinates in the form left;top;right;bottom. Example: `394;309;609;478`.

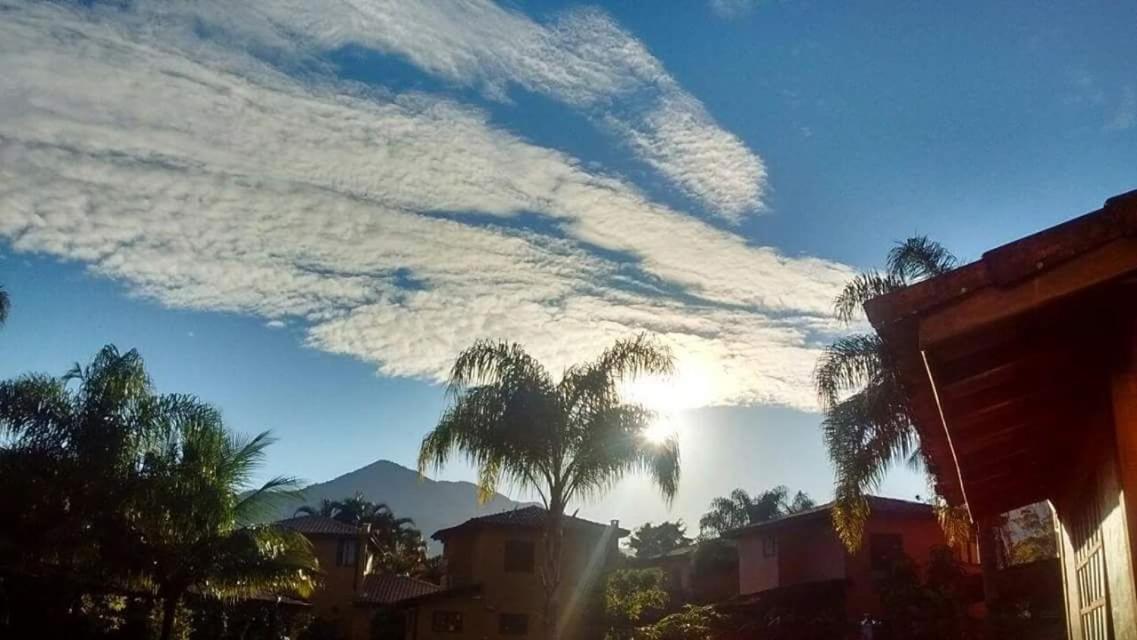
0;0;1137;532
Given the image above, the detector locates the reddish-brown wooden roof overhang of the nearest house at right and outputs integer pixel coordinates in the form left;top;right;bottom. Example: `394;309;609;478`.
865;191;1137;517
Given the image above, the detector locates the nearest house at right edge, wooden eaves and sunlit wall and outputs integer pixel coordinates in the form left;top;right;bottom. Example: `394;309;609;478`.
865;191;1137;640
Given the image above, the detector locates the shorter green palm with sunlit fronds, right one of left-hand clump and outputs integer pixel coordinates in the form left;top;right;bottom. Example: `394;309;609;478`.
138;420;317;640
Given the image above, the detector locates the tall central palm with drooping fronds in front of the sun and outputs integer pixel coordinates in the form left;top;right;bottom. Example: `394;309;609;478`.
418;334;679;640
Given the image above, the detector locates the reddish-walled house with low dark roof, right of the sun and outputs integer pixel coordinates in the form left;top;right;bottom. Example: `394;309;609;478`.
725;497;978;621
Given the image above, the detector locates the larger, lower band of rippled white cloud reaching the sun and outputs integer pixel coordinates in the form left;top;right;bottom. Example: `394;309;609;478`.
0;0;850;409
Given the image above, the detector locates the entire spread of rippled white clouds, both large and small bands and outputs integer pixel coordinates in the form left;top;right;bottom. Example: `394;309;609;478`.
0;0;850;408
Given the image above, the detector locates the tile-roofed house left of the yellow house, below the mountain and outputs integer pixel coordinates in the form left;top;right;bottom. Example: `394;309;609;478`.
276;516;441;640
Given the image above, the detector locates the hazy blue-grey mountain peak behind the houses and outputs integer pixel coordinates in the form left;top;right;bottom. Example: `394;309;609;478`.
271;460;531;552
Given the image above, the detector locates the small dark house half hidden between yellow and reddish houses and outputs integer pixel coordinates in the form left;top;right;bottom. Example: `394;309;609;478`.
630;539;738;604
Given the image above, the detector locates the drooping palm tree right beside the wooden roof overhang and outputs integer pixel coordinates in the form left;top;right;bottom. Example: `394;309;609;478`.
814;236;956;549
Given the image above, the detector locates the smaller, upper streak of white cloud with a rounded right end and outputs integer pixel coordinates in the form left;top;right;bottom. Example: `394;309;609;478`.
153;0;766;222
